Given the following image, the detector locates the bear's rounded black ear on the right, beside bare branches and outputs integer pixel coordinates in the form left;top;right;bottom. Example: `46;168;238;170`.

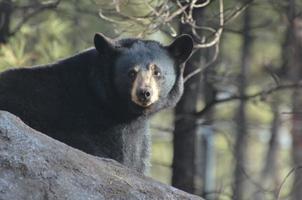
167;34;193;64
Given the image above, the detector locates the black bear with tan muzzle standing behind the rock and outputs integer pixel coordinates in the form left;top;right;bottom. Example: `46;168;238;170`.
0;33;193;173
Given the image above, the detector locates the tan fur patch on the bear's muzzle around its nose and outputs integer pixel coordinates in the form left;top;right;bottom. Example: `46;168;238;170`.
131;65;160;107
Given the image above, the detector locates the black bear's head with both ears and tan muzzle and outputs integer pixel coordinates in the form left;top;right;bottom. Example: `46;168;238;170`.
94;33;193;114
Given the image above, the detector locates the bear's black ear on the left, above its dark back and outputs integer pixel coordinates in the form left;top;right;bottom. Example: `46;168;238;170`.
94;33;114;55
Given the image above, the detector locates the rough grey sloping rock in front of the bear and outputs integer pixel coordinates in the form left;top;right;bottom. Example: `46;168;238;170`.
0;111;201;200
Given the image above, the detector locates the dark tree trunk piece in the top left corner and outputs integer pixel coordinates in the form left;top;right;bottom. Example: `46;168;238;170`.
0;0;13;44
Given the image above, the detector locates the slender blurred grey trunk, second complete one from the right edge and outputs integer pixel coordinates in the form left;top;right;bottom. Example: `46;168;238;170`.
233;5;252;200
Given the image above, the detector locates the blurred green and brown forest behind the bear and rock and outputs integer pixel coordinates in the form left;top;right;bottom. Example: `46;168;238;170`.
0;0;302;200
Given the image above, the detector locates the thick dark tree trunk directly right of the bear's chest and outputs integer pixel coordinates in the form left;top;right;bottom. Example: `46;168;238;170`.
172;3;202;193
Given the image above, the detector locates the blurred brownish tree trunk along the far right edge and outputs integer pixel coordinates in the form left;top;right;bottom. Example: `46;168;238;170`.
283;0;302;200
